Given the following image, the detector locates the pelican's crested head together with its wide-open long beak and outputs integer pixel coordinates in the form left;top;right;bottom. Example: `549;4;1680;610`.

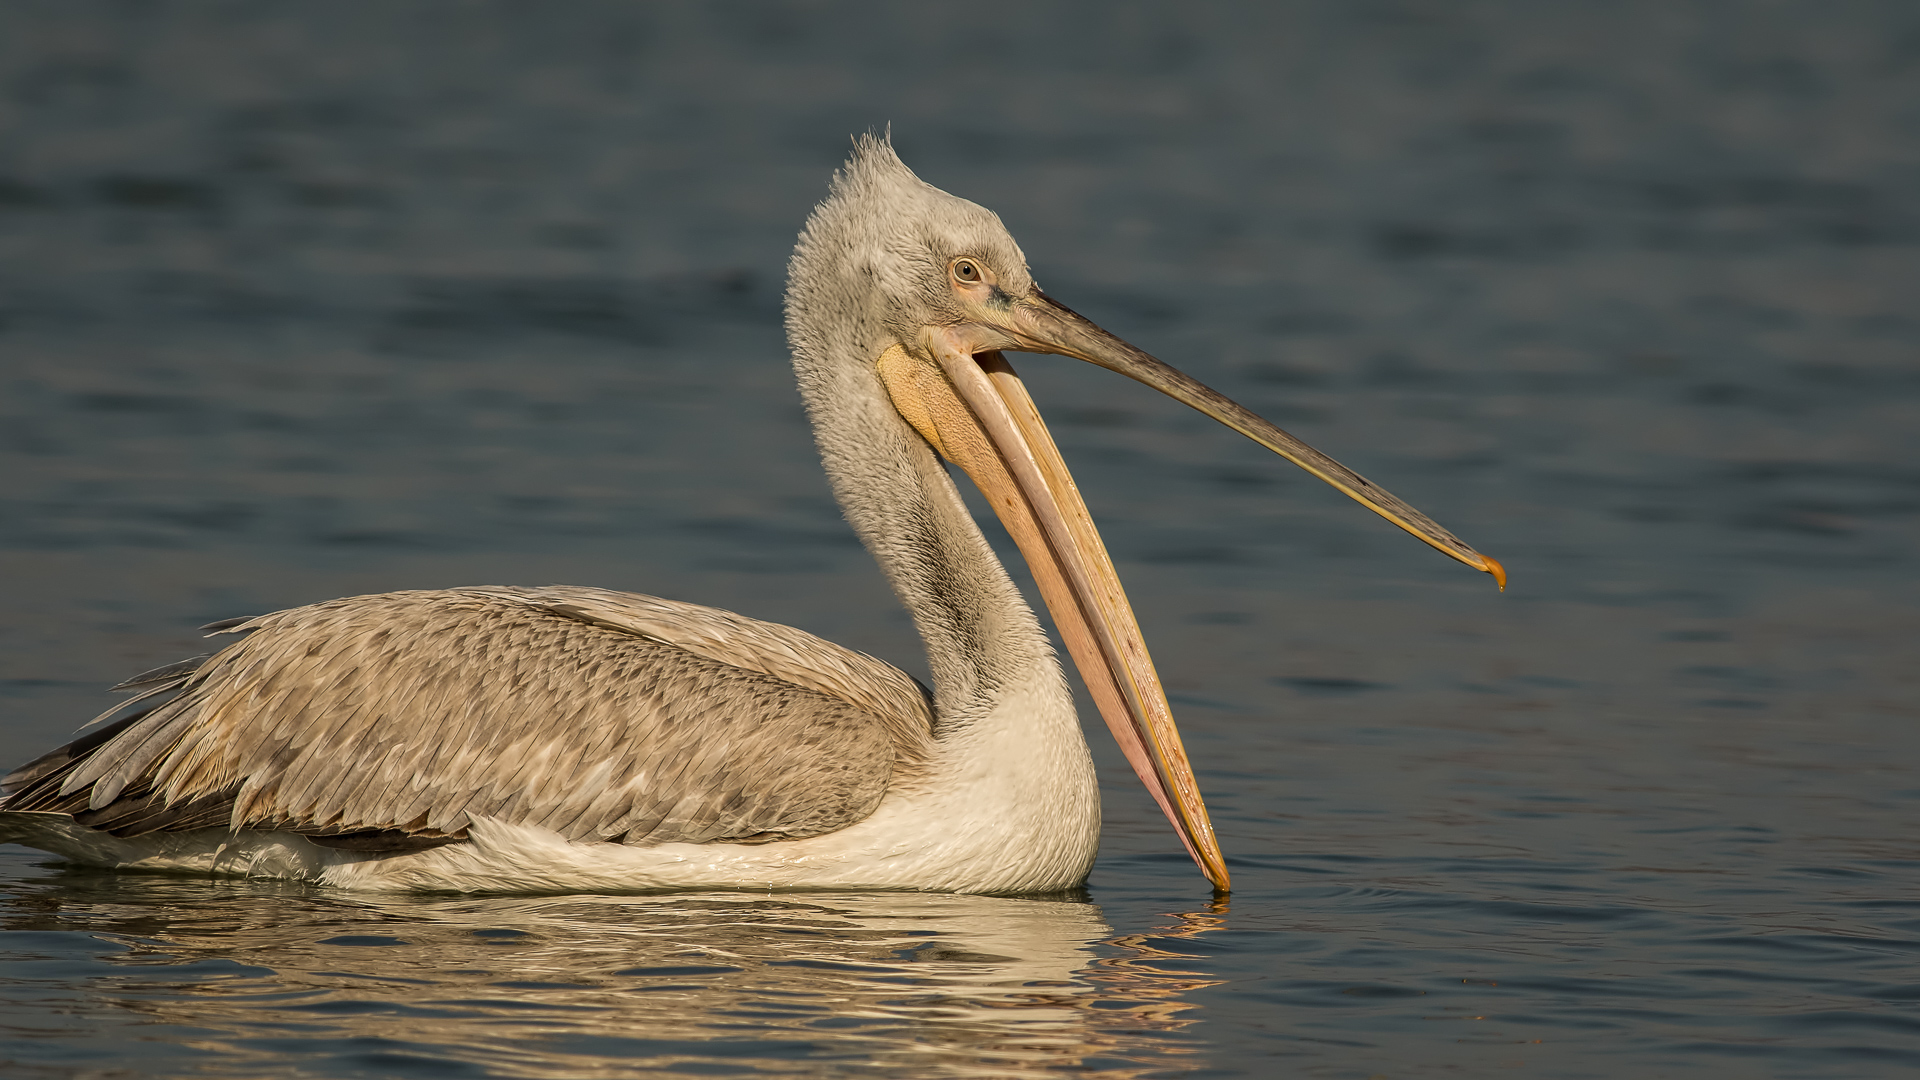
787;136;1505;890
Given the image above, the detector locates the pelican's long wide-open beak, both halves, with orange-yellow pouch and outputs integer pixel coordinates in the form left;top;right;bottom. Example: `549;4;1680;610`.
877;288;1505;892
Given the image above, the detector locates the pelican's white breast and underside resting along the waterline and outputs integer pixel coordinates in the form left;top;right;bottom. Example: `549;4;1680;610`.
0;671;1100;894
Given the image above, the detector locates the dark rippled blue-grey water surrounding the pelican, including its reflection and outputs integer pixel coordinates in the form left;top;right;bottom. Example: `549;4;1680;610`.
0;0;1920;1078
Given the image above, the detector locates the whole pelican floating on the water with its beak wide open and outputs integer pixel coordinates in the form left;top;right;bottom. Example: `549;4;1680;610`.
0;135;1505;894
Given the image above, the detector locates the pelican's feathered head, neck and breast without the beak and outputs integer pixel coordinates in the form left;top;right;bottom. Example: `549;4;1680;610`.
787;140;1098;867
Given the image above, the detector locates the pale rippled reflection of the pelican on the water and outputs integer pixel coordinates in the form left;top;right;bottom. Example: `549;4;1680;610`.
0;871;1223;1076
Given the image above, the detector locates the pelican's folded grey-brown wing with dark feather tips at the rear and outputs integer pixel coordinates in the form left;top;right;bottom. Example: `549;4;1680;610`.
6;586;933;849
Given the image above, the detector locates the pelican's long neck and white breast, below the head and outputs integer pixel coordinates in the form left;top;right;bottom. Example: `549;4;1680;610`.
795;340;1100;880
